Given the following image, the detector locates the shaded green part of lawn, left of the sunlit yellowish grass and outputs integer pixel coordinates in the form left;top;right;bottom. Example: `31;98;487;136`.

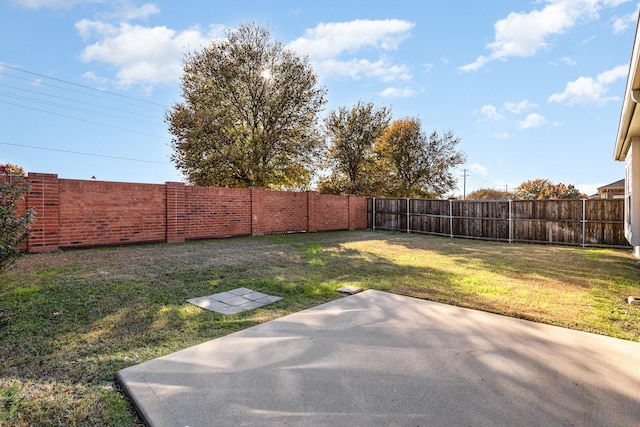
0;233;460;425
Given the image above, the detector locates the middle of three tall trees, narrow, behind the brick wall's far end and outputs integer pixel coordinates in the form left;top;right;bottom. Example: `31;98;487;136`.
318;101;391;196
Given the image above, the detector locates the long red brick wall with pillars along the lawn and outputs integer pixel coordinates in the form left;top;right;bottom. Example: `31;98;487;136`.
20;173;367;252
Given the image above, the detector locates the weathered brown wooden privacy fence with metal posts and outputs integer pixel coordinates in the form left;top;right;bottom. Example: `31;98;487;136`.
368;198;630;247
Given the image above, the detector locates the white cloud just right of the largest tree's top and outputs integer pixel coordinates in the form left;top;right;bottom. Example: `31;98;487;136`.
287;19;414;82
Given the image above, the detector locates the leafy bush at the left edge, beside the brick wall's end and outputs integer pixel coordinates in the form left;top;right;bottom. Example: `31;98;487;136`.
0;165;34;271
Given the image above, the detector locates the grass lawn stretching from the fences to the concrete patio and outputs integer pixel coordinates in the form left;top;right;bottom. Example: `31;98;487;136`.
0;231;640;426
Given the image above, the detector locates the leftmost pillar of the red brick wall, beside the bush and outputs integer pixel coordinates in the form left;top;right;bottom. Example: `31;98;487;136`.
27;172;60;252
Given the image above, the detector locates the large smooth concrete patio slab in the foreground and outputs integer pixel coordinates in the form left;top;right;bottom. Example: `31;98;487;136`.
117;290;640;427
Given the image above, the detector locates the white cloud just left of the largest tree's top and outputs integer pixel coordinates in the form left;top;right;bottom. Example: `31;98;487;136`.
76;19;218;86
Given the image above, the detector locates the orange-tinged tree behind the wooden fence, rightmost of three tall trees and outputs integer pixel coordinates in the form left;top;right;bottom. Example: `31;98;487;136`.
375;117;466;198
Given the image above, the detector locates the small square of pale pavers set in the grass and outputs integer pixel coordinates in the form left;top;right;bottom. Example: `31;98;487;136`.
187;288;282;314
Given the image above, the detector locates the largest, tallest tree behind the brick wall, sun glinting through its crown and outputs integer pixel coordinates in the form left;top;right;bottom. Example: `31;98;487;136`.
166;24;326;188
